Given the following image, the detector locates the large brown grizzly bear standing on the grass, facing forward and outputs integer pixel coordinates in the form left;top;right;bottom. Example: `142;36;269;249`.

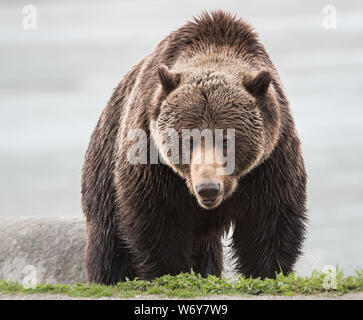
82;11;307;284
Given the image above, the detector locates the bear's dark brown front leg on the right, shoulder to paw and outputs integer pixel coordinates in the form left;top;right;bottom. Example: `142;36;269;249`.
232;129;307;278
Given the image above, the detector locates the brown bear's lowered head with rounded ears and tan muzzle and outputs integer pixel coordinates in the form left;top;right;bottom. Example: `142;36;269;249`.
150;66;280;209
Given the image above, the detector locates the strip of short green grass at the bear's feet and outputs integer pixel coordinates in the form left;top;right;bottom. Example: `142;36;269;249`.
0;269;363;298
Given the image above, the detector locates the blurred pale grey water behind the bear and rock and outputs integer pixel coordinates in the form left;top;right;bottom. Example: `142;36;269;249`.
0;0;363;274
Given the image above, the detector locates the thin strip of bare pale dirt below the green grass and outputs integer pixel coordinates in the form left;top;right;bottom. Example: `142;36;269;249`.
0;292;363;300
